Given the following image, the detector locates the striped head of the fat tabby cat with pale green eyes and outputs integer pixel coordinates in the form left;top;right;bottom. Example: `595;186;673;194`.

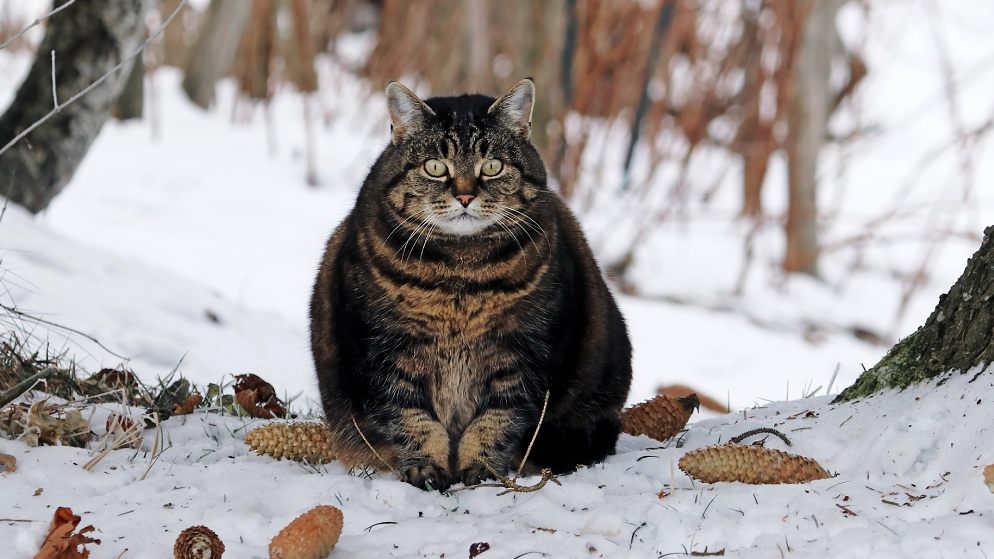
381;79;546;236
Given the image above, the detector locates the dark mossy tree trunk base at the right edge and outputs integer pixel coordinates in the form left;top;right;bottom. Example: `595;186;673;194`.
838;226;994;400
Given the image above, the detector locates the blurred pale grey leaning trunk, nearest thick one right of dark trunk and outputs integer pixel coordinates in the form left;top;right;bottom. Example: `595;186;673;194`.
183;0;252;109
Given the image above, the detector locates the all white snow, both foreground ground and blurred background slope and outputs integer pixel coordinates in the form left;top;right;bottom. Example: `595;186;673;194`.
0;0;994;559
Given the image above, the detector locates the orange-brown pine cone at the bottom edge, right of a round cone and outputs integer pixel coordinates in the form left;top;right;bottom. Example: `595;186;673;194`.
269;505;344;559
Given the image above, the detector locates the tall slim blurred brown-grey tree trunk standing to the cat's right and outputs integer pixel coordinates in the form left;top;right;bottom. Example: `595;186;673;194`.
783;0;842;275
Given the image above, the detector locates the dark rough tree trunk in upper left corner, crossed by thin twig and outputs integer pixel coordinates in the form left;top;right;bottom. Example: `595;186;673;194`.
0;0;148;213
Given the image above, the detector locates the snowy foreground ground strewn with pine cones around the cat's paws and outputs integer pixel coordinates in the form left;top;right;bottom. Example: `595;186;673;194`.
0;368;994;559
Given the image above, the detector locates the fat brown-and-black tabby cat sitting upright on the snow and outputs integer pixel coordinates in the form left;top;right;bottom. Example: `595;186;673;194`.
311;79;631;490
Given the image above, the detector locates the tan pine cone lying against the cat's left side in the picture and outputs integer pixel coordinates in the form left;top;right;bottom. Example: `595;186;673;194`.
245;422;335;464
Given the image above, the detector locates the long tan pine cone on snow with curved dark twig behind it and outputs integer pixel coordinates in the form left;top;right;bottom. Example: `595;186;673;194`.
678;443;831;484
